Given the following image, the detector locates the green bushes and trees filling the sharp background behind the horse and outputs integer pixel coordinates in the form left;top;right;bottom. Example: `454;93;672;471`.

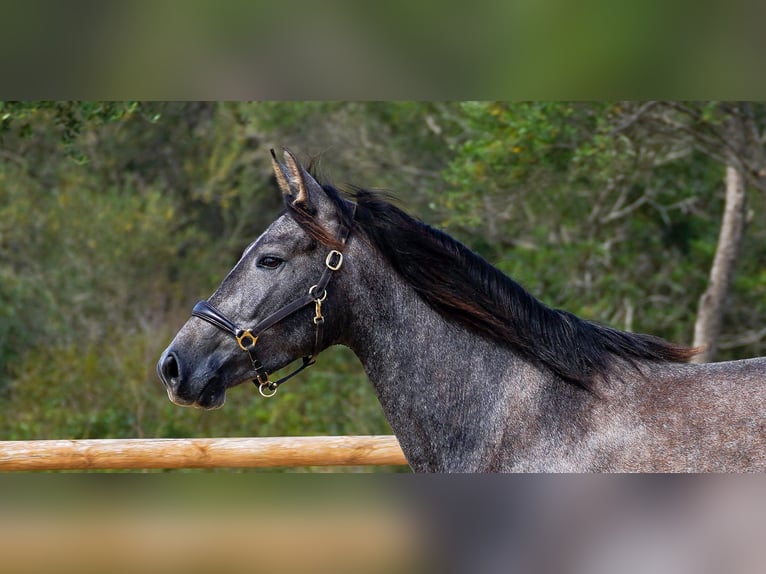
0;102;766;468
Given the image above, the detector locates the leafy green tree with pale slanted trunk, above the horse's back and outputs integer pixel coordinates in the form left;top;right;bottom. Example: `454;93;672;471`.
448;102;766;359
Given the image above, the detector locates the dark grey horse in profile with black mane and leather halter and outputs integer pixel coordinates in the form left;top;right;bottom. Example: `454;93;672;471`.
157;150;766;473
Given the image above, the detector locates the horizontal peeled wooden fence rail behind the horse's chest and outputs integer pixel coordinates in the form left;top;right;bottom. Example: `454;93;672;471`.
0;435;407;471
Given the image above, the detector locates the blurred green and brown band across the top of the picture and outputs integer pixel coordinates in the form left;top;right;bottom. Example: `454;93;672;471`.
0;0;766;100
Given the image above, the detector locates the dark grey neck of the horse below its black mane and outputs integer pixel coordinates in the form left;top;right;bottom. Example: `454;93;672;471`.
340;238;568;471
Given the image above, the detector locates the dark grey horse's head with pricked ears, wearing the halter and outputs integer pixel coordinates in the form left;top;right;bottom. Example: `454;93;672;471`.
157;151;352;409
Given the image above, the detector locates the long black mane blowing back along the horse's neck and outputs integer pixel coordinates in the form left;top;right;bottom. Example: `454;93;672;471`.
296;186;695;389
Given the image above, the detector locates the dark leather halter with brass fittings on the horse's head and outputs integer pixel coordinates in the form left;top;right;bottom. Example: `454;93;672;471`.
192;226;350;398
